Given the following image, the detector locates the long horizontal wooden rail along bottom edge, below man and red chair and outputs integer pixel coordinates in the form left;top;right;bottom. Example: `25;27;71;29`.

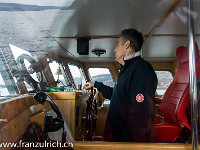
70;141;193;150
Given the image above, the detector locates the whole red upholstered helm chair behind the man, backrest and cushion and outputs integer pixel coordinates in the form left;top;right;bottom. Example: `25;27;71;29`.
155;43;200;142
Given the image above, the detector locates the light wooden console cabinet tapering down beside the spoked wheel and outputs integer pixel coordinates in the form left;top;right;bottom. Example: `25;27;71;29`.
50;91;89;140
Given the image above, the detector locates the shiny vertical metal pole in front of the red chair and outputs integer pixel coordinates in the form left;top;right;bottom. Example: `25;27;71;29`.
187;0;198;150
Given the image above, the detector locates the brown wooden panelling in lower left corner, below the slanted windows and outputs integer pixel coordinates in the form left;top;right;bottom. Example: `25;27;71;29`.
0;94;50;143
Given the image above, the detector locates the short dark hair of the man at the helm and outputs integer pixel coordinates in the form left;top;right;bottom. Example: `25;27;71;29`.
120;28;143;52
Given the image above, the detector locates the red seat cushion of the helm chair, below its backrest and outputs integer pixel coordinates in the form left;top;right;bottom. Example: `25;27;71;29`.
155;116;182;142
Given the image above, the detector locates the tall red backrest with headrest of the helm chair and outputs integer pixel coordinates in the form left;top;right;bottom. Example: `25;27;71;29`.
160;43;200;129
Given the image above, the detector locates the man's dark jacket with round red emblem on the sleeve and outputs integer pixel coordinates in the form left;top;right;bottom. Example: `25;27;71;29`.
94;56;157;142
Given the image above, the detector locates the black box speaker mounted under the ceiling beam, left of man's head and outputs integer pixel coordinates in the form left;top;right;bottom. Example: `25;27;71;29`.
77;37;89;55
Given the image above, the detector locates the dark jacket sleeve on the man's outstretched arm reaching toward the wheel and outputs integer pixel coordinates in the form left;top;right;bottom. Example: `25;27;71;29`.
94;81;113;99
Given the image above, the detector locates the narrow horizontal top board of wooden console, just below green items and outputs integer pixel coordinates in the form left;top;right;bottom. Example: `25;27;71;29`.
49;92;75;100
